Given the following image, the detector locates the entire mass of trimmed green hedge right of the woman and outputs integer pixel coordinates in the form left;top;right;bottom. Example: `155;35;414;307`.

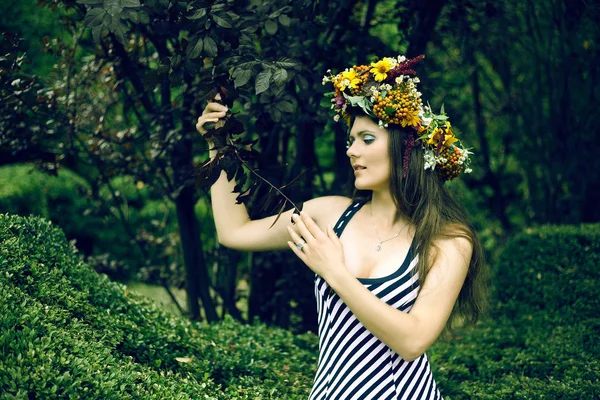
430;224;600;400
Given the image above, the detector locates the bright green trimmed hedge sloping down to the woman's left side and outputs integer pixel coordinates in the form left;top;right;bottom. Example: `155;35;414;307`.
0;215;317;399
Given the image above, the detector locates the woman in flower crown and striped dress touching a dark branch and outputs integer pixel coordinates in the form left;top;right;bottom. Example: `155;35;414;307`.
197;56;485;400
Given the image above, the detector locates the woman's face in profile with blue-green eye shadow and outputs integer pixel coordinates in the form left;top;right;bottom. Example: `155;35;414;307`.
346;116;390;191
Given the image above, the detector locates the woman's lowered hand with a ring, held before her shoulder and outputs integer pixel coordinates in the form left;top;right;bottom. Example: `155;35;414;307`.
288;212;346;280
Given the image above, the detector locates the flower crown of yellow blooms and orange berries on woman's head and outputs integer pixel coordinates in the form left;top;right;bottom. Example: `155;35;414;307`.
323;55;473;181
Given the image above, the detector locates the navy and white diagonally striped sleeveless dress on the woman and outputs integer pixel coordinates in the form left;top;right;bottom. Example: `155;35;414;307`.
309;202;442;400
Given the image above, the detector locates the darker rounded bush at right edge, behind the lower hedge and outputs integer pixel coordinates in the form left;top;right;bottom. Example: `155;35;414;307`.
494;224;600;322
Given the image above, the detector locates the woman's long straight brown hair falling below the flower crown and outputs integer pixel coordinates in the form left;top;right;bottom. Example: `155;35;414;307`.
353;120;487;331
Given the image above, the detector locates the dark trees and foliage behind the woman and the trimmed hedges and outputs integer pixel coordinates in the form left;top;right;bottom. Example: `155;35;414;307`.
0;0;600;331
